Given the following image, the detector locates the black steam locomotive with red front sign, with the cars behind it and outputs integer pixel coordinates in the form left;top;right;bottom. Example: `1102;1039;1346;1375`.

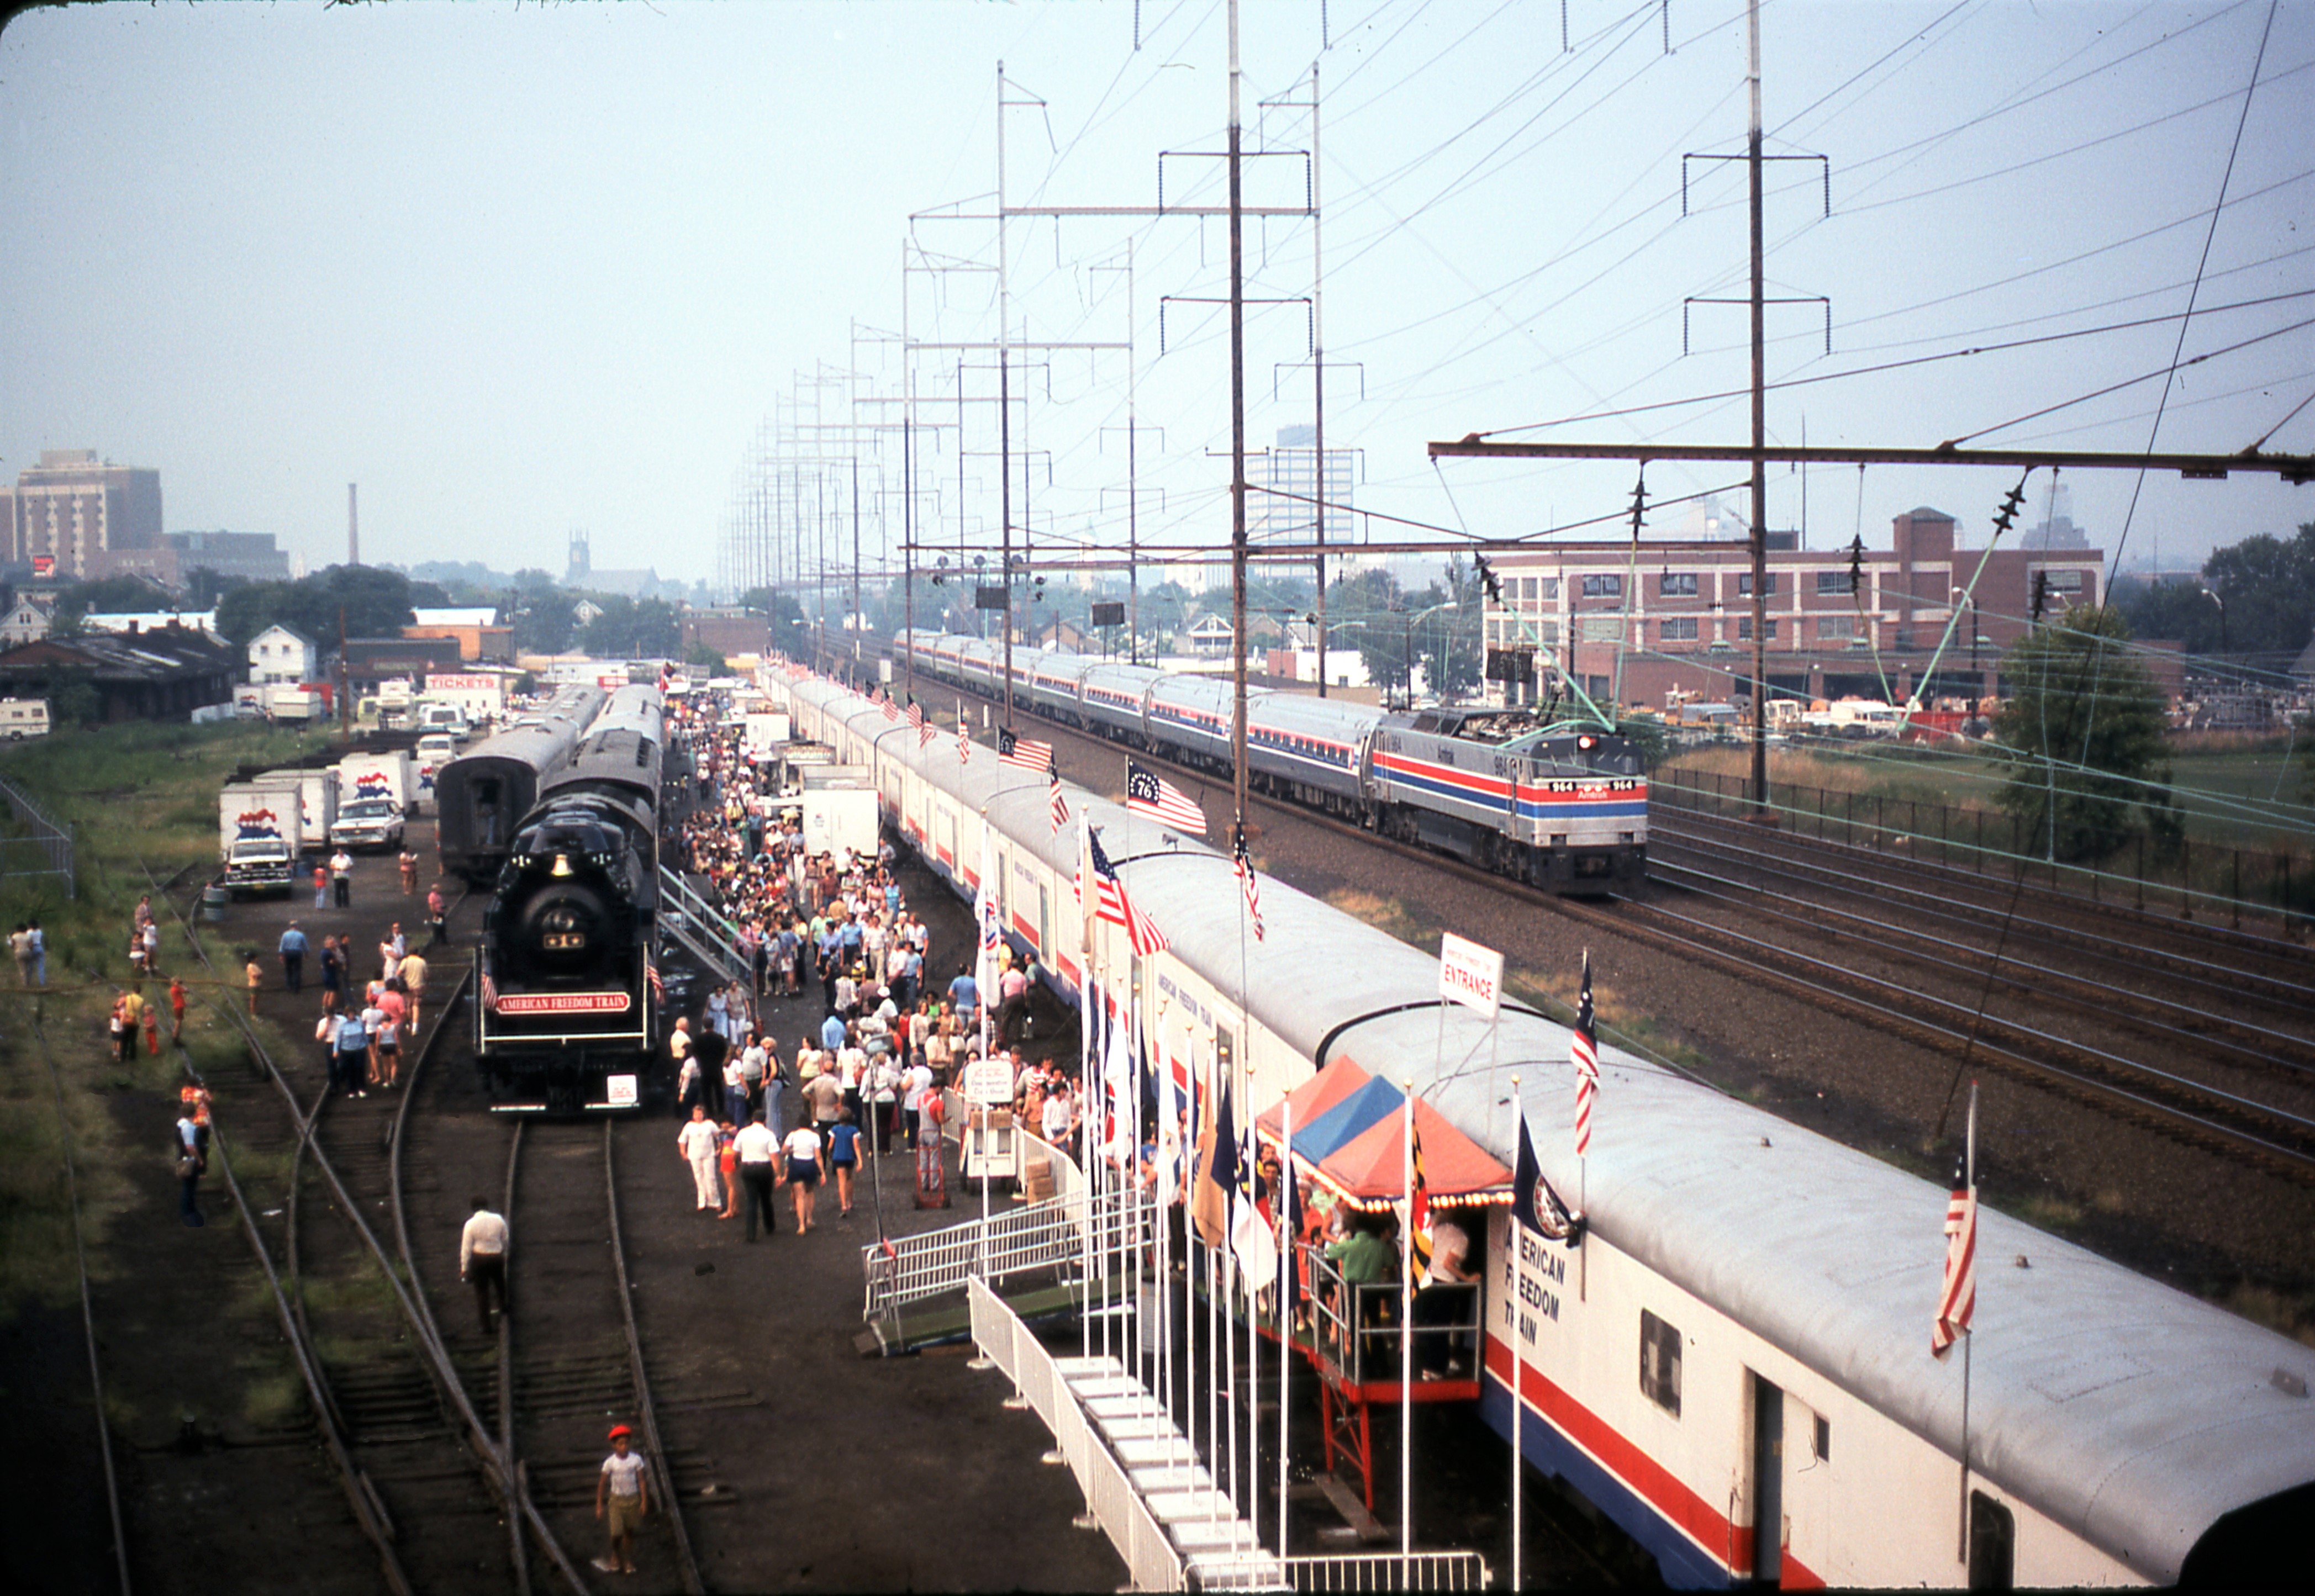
474;687;665;1113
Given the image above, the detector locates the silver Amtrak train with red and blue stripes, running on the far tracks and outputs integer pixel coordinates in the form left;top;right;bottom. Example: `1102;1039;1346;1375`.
898;631;1648;893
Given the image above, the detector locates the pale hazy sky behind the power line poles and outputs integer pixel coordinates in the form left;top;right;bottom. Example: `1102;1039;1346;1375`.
0;0;2315;590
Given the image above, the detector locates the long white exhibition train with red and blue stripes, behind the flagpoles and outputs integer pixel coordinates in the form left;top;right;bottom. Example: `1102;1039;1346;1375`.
778;657;2315;1589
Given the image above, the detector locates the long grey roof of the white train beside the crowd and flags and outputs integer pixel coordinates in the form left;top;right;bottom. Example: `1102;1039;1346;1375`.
797;666;2315;1582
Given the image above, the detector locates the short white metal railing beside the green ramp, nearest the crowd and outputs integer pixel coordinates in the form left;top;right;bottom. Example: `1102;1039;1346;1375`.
861;1191;1153;1321
